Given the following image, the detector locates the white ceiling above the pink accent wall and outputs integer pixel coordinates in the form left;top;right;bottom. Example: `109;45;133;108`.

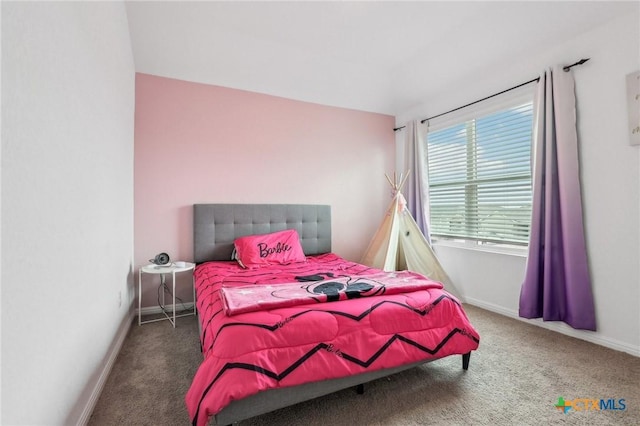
126;1;638;115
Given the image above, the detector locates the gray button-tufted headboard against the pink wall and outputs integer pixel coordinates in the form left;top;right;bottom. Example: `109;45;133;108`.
193;204;331;263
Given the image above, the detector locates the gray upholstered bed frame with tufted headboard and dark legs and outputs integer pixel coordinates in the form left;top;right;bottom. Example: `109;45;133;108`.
193;204;471;425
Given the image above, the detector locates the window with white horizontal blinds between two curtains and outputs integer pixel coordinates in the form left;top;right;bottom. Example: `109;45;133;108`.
427;91;533;246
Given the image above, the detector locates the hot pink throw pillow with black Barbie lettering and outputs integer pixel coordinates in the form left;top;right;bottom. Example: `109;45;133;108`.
234;229;306;269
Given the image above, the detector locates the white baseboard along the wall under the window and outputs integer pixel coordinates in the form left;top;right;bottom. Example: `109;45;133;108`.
465;297;640;357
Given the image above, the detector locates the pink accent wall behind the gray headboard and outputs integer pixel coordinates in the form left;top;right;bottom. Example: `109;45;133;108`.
134;73;395;306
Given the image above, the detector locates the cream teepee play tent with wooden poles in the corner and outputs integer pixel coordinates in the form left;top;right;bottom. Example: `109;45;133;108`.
360;173;460;298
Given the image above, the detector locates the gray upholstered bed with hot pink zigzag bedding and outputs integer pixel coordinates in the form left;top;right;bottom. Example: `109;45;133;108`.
185;204;479;425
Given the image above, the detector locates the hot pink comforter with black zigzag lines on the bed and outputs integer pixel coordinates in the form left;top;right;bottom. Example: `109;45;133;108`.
185;254;479;425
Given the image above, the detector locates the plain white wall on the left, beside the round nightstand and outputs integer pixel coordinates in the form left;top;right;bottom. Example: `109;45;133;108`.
0;2;135;425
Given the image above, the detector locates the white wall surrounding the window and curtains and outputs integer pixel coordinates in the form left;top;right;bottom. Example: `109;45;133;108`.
397;12;640;355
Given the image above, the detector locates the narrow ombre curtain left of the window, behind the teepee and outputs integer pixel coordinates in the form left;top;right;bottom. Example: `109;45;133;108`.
402;120;431;243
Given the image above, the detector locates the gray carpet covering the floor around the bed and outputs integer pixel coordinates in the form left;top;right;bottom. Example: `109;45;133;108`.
89;305;640;426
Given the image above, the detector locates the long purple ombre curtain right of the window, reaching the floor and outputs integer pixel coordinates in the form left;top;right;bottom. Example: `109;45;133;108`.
520;67;596;331
